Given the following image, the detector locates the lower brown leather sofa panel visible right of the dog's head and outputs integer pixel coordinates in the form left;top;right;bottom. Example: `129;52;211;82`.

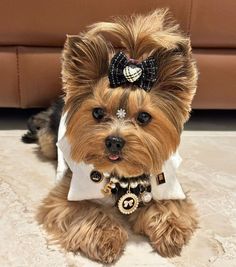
193;49;236;109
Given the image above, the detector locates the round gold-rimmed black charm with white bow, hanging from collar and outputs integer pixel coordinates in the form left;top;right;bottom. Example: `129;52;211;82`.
118;193;139;214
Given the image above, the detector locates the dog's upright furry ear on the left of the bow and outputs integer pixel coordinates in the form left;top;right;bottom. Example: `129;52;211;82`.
62;34;109;105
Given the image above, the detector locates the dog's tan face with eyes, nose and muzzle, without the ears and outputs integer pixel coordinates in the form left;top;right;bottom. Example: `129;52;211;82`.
64;81;179;176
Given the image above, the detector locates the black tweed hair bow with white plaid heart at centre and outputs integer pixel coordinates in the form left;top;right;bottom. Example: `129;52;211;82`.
108;52;157;91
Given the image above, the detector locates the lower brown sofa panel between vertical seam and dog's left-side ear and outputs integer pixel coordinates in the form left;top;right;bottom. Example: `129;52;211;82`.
18;47;62;108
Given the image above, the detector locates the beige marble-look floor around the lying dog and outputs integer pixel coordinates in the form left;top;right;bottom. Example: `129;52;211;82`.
0;130;236;267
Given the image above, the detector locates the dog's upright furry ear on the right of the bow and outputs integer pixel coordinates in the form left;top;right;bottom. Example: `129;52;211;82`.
150;39;198;122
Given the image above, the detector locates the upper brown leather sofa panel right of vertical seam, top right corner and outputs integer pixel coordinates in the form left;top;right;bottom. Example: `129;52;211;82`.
190;0;236;48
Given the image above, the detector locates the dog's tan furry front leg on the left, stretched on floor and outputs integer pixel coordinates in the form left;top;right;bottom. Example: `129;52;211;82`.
37;175;128;263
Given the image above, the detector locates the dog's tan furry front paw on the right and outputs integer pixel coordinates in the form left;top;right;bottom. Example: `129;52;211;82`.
134;200;198;257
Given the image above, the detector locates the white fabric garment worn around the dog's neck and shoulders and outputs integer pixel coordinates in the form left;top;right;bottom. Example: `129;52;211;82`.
57;114;185;201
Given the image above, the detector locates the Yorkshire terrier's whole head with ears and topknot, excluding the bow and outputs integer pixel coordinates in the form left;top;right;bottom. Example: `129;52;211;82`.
62;10;197;177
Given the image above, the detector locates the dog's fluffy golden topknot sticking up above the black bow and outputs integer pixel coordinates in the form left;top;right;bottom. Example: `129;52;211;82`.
87;9;189;59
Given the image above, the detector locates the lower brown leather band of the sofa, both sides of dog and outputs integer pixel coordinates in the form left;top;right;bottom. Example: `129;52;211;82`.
0;47;236;109
